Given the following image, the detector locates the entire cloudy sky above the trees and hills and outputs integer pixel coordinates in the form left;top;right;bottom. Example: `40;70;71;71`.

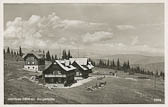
4;3;164;55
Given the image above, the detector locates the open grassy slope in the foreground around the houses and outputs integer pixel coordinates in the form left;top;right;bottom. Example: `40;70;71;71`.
4;60;164;104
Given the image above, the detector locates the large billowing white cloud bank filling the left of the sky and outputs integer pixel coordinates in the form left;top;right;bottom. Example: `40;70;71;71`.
4;13;108;48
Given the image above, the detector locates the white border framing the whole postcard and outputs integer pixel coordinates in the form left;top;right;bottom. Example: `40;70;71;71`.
0;0;168;107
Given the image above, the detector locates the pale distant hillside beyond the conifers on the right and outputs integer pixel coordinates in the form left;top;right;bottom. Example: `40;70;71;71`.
90;54;164;72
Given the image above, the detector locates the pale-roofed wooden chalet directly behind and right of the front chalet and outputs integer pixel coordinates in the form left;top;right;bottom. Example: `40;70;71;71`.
70;58;94;78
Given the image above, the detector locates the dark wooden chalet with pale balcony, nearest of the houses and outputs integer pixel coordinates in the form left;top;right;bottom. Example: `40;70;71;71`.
42;60;76;86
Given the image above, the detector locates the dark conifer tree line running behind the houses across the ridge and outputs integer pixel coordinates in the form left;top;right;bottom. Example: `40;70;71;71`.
4;46;165;78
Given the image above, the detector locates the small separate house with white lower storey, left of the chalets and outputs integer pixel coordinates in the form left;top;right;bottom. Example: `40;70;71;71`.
23;51;45;71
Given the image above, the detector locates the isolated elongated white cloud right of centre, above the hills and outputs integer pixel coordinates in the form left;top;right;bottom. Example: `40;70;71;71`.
83;31;113;43
